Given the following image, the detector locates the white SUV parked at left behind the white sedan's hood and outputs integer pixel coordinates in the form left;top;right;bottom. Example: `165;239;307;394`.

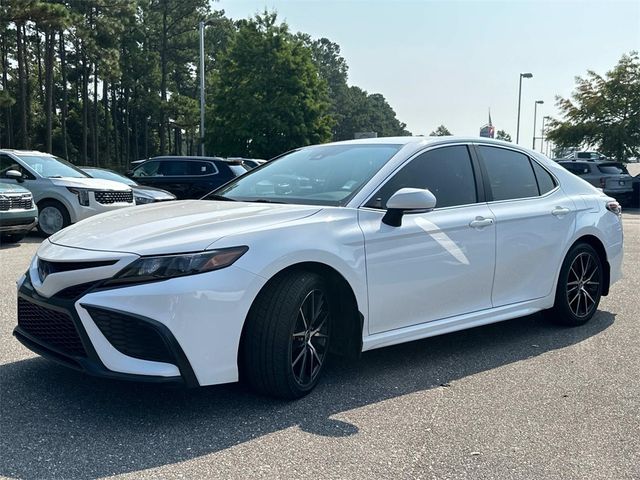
0;150;134;236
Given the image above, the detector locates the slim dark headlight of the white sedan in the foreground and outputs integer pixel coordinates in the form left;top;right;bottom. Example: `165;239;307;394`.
103;246;249;286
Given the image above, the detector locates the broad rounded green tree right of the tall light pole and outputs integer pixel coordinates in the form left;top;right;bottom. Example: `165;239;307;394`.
206;12;331;158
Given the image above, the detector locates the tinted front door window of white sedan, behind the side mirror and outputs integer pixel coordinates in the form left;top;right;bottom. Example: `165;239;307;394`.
367;146;477;208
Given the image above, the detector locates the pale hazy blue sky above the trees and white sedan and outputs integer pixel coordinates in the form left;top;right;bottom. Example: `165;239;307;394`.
212;0;640;149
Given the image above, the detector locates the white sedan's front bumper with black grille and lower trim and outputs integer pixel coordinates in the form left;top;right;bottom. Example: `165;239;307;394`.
15;240;265;385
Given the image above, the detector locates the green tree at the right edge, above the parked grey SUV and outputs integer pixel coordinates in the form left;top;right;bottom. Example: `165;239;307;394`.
547;52;640;161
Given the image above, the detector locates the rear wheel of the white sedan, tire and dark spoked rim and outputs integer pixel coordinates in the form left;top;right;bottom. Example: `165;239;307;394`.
546;243;604;326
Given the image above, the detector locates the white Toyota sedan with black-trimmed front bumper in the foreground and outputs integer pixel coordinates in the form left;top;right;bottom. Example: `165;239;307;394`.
14;137;623;398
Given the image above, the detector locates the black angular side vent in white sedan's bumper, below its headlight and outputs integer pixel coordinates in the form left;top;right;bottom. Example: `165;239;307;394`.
85;306;175;363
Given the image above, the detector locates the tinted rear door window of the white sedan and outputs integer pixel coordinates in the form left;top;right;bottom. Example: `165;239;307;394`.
479;146;538;200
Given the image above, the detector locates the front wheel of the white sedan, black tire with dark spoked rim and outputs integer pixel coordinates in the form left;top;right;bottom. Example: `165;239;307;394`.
242;272;332;399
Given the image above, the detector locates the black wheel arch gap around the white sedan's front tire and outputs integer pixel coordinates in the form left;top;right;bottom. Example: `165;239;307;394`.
238;261;364;368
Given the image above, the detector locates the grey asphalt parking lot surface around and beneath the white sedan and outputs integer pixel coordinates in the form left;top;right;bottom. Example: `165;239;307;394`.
0;215;640;479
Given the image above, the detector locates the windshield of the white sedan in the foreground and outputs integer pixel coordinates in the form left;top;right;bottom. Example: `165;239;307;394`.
205;144;402;206
